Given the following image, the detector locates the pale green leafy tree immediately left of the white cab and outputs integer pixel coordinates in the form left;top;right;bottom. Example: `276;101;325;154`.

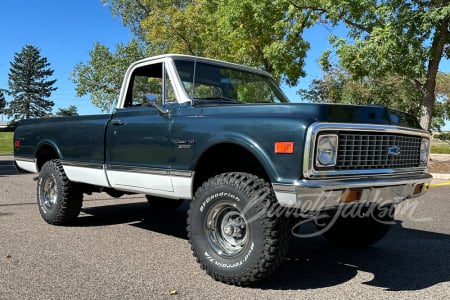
72;39;151;112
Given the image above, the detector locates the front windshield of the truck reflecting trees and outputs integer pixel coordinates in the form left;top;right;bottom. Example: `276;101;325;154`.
175;60;289;103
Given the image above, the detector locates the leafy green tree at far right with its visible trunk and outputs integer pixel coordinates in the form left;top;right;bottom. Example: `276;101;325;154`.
292;0;450;129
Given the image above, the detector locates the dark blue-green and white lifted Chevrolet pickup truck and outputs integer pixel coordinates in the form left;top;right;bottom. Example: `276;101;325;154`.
14;55;431;285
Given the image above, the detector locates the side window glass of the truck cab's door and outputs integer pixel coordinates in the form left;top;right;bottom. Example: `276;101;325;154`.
125;63;176;107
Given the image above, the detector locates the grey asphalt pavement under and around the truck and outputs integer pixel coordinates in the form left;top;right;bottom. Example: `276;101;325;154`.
0;156;450;300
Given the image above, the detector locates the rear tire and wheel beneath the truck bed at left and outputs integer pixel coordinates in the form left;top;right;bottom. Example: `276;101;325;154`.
37;159;83;225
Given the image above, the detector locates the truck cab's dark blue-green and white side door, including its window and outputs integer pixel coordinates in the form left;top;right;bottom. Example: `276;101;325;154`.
105;62;175;194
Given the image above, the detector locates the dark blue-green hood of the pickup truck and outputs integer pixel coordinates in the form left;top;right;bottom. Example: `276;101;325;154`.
203;103;422;129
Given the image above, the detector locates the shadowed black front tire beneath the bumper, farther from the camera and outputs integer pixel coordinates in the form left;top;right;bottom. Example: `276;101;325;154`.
317;206;395;248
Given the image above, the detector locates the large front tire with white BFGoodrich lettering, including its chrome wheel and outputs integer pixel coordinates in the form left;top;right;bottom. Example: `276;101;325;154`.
187;173;289;285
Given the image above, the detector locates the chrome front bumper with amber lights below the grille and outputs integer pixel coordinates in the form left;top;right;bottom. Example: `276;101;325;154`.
273;173;432;211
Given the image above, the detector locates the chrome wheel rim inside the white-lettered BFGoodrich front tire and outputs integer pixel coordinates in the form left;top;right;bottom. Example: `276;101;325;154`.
205;203;249;257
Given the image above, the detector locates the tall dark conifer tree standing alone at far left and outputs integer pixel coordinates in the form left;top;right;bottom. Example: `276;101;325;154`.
6;45;57;121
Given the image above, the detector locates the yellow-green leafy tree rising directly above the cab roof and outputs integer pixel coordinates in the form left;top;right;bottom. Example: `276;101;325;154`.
139;0;316;85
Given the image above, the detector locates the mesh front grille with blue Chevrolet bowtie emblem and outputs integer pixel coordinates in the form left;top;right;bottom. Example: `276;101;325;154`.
335;132;421;170
